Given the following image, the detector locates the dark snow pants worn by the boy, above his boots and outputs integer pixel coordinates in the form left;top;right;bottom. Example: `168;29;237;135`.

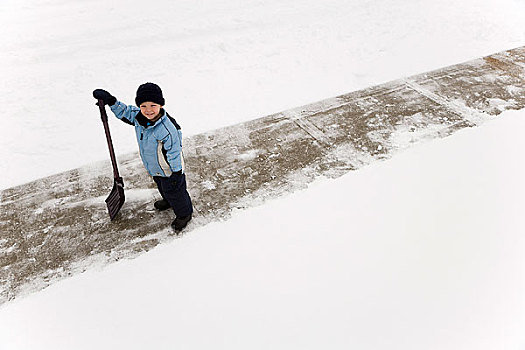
153;171;193;217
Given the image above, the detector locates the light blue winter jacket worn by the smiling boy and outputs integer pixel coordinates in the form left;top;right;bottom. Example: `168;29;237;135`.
110;101;184;177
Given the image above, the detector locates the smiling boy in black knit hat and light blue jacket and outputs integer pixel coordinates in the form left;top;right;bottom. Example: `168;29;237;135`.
93;83;193;232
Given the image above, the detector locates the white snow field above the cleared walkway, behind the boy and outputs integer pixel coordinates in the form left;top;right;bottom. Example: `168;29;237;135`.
0;0;525;188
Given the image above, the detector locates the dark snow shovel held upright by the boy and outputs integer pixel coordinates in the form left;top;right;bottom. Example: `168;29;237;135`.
97;100;126;220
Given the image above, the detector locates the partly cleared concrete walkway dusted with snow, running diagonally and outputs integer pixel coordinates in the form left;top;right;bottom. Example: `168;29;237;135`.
0;47;525;305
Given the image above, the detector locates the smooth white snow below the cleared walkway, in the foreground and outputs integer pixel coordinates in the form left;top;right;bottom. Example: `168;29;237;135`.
0;110;525;350
